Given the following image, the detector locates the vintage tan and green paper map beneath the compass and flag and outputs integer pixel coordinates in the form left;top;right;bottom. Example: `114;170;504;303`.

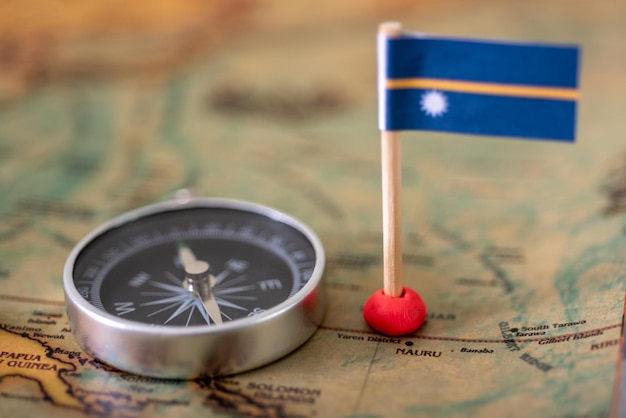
0;0;626;418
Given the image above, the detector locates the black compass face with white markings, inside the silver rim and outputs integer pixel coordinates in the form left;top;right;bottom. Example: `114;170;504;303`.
73;202;316;327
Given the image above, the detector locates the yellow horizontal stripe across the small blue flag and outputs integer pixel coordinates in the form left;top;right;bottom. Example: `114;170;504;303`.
385;78;578;100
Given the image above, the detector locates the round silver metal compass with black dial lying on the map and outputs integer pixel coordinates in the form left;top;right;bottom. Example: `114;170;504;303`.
63;199;326;379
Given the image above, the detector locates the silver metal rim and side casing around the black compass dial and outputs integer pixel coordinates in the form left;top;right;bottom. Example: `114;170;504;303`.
63;198;326;378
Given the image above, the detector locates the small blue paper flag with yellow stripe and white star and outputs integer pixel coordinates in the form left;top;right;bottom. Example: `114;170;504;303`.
378;29;579;142
